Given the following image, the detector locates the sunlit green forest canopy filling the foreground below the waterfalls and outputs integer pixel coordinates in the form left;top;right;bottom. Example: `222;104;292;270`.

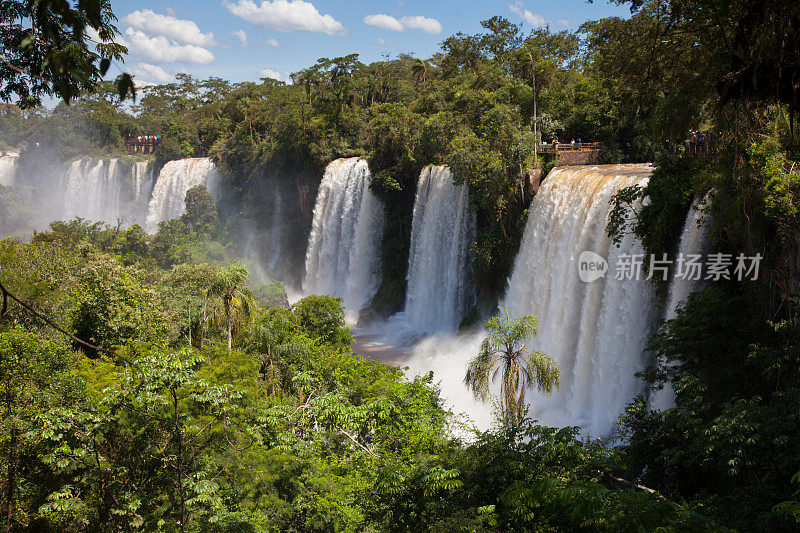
0;219;704;531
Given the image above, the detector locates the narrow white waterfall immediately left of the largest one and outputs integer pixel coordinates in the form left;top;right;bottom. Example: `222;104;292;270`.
405;165;475;333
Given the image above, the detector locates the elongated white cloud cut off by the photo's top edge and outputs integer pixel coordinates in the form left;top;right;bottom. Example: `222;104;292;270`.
225;0;347;35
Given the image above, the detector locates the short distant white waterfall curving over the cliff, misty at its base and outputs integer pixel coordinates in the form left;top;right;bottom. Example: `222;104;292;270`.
145;157;220;233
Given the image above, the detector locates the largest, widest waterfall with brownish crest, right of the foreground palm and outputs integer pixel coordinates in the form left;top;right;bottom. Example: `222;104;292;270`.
504;164;658;435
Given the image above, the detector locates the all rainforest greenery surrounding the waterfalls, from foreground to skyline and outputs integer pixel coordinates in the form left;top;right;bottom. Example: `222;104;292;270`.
0;0;800;532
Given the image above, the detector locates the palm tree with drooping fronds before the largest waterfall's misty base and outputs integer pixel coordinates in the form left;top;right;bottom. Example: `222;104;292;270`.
464;304;561;427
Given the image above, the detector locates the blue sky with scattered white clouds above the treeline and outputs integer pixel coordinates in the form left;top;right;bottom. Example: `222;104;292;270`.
106;0;629;83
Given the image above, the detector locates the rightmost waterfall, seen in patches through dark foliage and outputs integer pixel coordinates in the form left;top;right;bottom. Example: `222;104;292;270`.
650;198;711;411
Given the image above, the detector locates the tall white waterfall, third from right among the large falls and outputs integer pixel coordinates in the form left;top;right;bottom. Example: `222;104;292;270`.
303;158;383;320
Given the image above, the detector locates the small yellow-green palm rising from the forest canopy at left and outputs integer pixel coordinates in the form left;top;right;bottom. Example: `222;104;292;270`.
206;263;258;351
